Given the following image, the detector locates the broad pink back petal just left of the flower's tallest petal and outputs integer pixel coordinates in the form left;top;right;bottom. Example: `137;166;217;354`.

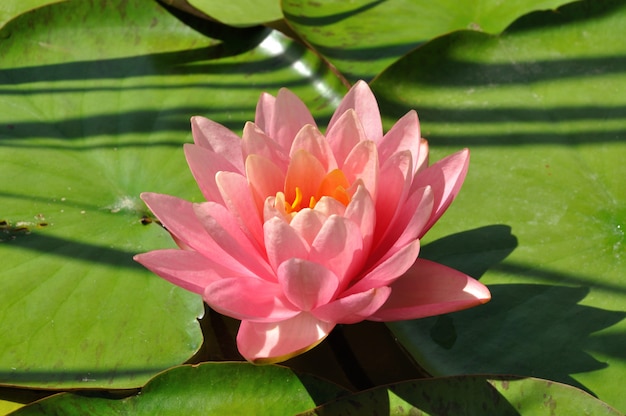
265;88;316;150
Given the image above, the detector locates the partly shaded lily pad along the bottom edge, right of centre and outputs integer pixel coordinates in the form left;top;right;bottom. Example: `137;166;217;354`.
302;376;620;416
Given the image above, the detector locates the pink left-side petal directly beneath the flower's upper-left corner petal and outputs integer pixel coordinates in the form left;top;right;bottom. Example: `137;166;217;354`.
184;144;238;202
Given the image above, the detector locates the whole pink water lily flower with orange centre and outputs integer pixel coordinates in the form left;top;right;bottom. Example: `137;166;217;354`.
135;81;490;363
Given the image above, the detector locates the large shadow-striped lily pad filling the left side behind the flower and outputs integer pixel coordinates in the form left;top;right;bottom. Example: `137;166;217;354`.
0;0;340;388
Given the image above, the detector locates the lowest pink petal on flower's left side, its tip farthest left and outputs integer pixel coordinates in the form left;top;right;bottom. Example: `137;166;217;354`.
133;249;236;295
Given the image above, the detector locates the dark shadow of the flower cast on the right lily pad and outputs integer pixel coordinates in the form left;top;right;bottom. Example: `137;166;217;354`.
389;226;626;394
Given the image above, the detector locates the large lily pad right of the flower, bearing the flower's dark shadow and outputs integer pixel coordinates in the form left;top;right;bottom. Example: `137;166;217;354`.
373;1;626;410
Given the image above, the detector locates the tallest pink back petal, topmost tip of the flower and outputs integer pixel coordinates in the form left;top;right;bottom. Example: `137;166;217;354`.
328;81;383;141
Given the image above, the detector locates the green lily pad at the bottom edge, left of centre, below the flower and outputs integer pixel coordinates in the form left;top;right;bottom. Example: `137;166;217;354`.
13;363;347;416
